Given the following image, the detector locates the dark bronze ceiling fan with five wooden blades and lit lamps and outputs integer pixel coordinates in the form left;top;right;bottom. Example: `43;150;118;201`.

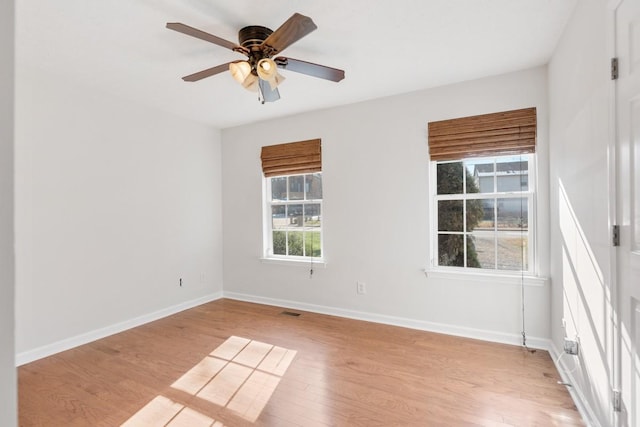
167;13;344;103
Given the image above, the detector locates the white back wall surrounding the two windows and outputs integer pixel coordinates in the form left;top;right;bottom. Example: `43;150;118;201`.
222;67;550;343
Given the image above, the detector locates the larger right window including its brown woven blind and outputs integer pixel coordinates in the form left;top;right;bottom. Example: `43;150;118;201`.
429;108;537;274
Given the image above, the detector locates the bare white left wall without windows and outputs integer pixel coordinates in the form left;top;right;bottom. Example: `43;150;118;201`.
15;65;222;362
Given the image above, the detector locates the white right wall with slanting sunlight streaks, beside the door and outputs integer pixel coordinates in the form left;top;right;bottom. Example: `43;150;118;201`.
549;1;612;425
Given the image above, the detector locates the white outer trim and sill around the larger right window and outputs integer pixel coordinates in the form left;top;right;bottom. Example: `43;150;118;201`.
424;153;536;280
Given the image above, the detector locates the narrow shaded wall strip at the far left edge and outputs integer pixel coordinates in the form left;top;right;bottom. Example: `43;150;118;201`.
0;0;18;426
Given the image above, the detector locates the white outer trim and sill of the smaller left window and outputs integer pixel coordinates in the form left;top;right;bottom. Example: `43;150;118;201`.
260;172;326;267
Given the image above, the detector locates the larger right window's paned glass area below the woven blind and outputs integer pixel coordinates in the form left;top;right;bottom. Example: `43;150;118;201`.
433;155;535;272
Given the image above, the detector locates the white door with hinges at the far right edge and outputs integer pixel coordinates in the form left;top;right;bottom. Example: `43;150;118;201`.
615;0;640;427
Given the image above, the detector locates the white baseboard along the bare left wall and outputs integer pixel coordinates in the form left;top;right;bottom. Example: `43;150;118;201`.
16;292;222;366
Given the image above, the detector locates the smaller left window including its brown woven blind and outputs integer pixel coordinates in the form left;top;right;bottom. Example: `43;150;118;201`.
261;139;323;260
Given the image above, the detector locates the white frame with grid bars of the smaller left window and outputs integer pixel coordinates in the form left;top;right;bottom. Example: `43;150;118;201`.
262;171;325;264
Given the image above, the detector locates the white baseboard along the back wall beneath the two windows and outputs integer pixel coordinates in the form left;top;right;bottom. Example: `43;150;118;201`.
223;291;551;350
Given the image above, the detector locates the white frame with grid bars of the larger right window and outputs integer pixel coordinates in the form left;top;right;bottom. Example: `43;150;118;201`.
425;153;539;277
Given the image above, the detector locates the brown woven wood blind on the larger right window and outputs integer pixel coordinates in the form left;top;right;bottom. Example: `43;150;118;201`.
429;107;537;160
